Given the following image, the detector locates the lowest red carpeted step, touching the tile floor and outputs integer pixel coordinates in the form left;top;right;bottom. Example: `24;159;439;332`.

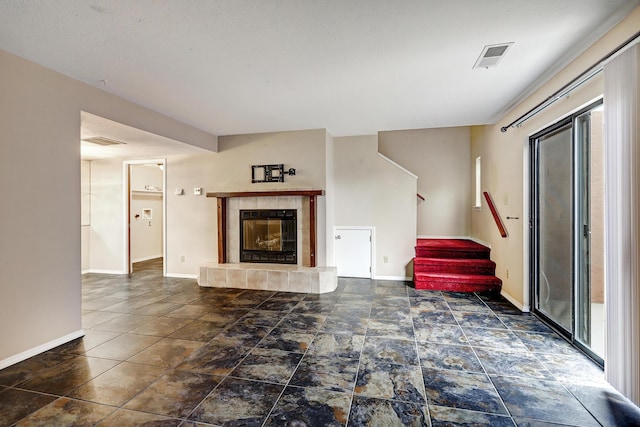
413;273;502;292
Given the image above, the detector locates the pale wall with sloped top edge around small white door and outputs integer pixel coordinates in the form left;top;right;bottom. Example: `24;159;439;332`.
334;135;417;280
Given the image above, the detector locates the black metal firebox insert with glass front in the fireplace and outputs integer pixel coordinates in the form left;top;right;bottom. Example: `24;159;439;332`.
240;209;298;264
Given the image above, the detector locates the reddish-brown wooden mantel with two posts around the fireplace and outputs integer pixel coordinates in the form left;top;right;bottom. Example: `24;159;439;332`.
207;190;324;267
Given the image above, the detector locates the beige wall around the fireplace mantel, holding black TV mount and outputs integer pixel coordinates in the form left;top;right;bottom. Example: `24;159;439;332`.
166;130;331;276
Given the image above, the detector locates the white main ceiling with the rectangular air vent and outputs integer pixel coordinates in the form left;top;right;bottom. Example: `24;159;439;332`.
0;0;640;150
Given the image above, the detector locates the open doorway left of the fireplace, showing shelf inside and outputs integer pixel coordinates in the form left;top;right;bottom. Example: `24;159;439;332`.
124;160;166;275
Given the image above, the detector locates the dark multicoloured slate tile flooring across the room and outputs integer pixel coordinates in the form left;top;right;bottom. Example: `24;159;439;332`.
0;260;640;427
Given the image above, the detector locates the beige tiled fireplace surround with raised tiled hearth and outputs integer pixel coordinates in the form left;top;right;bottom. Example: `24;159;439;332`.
198;192;338;293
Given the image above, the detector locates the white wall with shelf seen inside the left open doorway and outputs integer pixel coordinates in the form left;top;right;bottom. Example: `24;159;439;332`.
129;163;164;262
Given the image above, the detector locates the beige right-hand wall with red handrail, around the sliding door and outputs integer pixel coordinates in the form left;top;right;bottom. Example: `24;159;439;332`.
469;9;640;308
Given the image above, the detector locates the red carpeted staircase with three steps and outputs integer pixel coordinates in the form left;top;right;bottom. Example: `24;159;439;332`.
413;239;502;292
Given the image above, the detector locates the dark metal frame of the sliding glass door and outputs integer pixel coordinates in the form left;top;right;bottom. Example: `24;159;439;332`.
529;99;604;366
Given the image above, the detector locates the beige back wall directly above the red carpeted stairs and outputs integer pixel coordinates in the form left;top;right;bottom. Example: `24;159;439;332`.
378;127;472;237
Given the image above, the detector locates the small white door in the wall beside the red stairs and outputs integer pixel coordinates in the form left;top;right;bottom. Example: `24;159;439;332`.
335;227;373;278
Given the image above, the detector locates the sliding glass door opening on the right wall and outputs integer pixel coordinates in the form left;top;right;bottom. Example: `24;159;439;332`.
529;100;604;365
